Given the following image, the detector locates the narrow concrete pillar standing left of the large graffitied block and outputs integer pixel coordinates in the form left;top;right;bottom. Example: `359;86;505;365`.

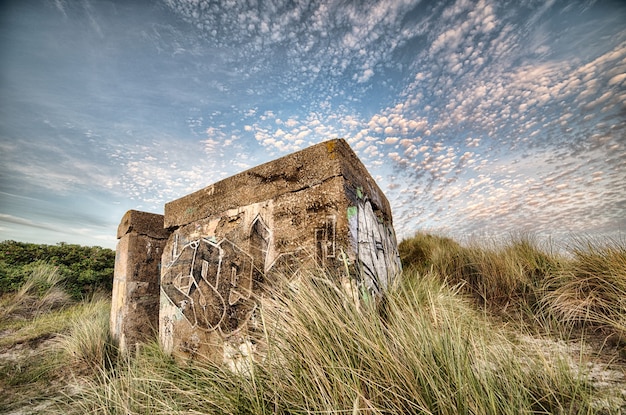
110;210;170;352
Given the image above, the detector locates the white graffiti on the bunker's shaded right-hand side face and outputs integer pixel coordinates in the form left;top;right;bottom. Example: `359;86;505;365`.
348;191;402;294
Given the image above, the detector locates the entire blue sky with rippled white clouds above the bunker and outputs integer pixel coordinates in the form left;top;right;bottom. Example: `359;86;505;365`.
0;0;626;248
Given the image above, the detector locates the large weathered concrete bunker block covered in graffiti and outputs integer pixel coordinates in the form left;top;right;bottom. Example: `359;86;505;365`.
159;140;400;360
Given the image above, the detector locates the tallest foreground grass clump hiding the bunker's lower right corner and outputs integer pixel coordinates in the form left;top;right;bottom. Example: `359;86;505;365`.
258;274;585;414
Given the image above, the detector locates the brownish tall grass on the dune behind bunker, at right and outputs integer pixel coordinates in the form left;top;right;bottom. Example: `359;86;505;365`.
400;233;626;341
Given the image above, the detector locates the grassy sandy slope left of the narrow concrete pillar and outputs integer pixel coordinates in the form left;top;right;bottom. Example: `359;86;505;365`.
0;264;110;412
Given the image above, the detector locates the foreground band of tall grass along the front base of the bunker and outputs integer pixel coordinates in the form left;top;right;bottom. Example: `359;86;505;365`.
63;271;591;414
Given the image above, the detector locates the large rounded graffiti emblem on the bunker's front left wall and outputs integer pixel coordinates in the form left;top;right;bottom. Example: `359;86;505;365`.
161;238;254;334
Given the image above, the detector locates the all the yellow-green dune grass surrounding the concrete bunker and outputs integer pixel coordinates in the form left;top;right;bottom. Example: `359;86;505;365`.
0;234;626;415
